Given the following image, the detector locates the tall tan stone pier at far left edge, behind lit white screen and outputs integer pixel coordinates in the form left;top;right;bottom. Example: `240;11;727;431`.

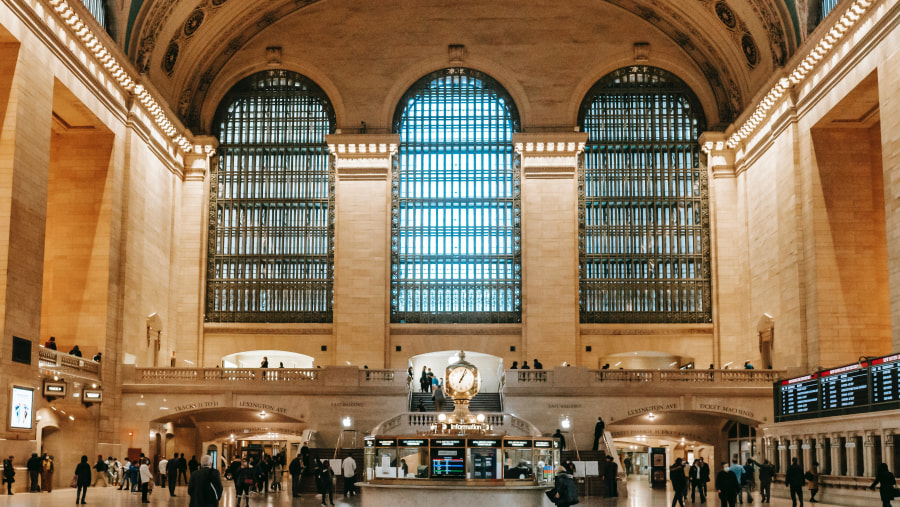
0;38;54;456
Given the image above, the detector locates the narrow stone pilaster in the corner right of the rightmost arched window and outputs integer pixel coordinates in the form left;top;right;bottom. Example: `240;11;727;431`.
700;132;740;368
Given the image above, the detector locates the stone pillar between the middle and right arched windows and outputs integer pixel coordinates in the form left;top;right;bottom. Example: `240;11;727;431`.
513;132;595;368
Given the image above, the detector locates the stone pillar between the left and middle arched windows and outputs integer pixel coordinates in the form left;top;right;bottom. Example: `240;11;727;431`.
325;134;394;368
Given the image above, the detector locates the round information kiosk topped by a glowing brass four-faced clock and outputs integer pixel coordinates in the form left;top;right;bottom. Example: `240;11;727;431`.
358;352;559;507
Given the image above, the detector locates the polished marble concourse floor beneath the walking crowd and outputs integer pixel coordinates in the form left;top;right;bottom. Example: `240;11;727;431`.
0;480;881;507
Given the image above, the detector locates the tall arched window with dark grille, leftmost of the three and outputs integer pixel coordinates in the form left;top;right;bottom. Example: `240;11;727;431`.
206;70;335;322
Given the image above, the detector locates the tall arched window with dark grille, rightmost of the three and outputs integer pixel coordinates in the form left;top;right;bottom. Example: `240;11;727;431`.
579;66;712;323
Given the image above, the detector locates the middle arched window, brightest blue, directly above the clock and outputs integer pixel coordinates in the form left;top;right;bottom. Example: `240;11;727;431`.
391;68;521;323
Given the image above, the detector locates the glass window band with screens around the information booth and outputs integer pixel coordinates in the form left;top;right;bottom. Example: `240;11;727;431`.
365;436;559;486
